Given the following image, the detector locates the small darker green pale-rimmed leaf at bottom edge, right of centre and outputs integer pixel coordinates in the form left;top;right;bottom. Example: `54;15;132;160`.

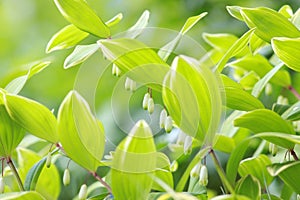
235;175;261;200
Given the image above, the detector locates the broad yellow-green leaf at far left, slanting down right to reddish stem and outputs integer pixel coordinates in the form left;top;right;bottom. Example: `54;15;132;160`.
5;94;58;143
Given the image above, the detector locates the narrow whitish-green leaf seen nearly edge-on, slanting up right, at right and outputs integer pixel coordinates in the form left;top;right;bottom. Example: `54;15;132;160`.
251;63;283;97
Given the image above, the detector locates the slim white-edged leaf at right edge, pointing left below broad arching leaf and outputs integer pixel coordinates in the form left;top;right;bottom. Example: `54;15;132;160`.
253;132;300;149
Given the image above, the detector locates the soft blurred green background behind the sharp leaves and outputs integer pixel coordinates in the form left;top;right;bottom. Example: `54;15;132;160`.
0;0;300;199
